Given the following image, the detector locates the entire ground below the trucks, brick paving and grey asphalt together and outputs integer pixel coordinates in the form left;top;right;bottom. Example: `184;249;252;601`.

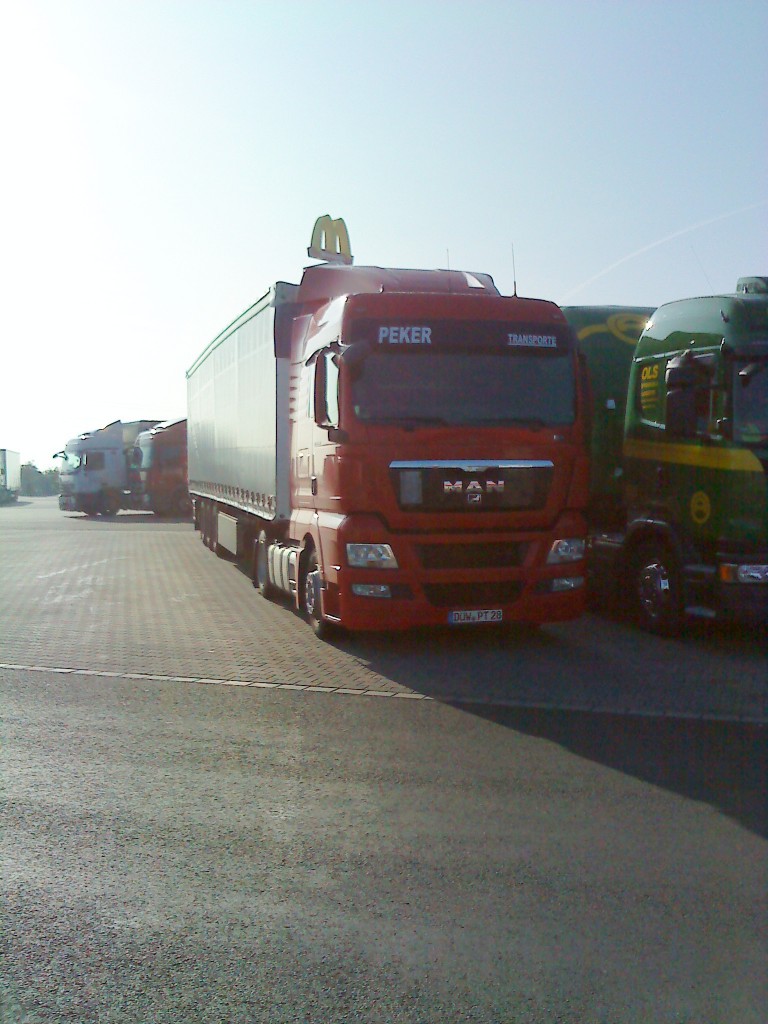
0;500;768;1024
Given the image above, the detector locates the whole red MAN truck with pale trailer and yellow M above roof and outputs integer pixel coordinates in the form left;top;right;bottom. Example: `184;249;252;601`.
187;218;589;636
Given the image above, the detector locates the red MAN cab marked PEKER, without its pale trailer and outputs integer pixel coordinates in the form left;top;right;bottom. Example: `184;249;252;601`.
290;276;586;629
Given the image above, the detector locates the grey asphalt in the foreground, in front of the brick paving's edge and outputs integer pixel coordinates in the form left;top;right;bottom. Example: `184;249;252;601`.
0;672;768;1024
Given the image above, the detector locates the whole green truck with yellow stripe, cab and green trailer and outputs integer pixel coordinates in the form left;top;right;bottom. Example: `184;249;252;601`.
563;278;768;635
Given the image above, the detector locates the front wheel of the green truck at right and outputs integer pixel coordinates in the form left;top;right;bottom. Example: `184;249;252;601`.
630;541;683;637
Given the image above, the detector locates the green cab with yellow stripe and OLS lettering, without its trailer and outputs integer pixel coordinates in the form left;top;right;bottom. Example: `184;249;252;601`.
624;278;768;632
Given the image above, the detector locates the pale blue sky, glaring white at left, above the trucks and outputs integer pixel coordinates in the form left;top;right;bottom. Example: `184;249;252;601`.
0;0;768;469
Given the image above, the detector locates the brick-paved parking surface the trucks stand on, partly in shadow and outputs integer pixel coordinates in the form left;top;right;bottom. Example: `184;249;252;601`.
0;499;768;721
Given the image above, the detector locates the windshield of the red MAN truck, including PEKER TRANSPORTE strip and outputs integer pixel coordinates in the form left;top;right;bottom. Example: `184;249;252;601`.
352;323;574;426
